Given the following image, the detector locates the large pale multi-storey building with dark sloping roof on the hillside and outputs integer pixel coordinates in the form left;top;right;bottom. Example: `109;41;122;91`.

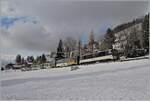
113;20;143;51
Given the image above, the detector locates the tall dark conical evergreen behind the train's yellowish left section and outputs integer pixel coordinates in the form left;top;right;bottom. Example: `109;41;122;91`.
56;39;64;59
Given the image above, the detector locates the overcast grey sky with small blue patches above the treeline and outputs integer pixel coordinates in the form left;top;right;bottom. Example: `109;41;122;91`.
0;0;149;61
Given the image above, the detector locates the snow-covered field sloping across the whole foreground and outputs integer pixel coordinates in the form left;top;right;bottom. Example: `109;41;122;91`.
0;59;150;100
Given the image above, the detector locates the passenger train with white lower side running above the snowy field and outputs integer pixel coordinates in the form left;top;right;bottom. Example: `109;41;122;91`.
53;50;116;67
